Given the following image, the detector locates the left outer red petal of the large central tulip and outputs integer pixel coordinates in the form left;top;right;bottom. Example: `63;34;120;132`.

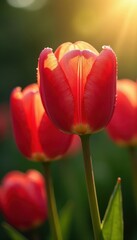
38;49;74;132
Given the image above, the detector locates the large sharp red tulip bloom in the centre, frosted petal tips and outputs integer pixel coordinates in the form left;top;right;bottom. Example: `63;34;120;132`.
38;42;116;134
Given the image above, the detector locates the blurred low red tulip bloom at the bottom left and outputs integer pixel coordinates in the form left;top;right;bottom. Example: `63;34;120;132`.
0;170;48;230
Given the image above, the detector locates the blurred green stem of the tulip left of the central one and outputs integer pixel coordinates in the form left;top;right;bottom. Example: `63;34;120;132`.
43;162;62;240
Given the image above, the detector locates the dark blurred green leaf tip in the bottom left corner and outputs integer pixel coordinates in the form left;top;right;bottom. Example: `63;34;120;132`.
3;223;27;240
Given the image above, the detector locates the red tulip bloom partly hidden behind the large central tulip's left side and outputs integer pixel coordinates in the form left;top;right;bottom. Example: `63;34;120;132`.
10;84;72;161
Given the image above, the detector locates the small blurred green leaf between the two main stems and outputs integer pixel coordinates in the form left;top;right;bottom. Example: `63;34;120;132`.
60;202;73;240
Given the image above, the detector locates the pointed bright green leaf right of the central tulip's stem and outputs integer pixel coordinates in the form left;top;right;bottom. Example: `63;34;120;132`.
102;178;123;240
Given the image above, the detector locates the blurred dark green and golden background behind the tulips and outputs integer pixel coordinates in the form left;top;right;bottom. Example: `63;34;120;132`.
0;0;137;240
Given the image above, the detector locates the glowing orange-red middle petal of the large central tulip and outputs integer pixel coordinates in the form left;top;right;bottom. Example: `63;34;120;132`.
60;50;97;125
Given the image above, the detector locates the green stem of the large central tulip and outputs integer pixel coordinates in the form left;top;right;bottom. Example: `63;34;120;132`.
81;135;103;240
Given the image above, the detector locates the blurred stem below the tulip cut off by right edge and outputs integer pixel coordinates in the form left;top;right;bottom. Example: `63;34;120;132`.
129;147;137;210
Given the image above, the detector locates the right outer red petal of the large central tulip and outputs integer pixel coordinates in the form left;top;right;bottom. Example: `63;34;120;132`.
83;47;116;131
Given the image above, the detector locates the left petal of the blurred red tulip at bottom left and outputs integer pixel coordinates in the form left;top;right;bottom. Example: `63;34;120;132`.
3;171;35;229
